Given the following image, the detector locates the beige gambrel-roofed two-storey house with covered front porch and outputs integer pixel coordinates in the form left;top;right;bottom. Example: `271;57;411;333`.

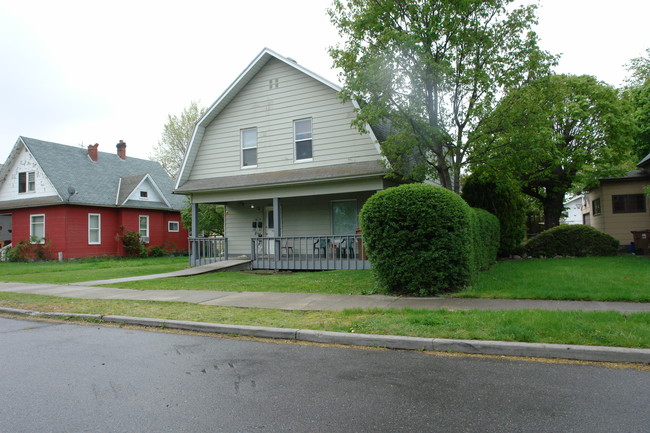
174;49;389;269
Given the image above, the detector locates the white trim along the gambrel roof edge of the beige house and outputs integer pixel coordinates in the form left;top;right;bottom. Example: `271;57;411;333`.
175;48;377;189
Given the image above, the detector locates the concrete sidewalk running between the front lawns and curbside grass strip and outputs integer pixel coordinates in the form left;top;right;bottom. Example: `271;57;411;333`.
0;278;650;313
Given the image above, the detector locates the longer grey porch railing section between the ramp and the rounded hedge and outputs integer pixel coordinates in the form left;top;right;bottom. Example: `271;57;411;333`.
251;235;370;270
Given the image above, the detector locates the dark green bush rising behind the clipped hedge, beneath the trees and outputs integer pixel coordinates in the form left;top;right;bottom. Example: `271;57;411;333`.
462;174;526;257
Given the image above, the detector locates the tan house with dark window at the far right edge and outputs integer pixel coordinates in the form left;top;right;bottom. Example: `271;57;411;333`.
582;154;650;246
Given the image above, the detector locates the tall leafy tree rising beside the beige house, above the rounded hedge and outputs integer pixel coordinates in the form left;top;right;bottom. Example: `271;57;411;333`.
329;0;554;192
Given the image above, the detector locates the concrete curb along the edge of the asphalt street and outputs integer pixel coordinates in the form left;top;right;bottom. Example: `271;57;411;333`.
0;307;650;364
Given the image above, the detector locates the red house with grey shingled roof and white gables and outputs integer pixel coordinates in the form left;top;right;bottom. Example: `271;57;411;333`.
0;137;188;258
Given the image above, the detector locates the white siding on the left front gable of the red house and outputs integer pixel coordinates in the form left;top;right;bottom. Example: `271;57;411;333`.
0;145;58;201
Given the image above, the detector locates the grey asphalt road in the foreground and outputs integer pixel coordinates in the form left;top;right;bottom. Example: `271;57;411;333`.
0;318;650;433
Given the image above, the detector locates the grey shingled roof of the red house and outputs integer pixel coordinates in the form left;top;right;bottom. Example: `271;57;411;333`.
0;137;184;210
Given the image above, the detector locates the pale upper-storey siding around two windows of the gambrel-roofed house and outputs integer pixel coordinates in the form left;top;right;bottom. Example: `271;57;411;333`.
190;59;379;180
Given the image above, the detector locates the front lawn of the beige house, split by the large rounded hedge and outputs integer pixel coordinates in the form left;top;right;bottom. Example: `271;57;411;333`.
96;256;650;302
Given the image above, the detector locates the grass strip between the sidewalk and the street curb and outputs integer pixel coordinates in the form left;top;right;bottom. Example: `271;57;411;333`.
0;293;650;348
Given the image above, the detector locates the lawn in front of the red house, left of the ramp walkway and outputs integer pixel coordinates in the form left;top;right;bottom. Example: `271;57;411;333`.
0;257;188;284
